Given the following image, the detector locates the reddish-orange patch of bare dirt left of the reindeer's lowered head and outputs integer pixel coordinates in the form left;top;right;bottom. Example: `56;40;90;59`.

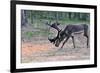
22;43;54;57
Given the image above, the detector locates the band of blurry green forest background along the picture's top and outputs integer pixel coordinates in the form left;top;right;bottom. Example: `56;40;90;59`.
23;10;90;25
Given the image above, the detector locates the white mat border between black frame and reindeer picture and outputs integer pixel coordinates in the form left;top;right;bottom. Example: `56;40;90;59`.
16;5;94;69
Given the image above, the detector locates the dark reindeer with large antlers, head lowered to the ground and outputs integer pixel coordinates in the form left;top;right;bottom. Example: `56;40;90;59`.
47;23;89;48
